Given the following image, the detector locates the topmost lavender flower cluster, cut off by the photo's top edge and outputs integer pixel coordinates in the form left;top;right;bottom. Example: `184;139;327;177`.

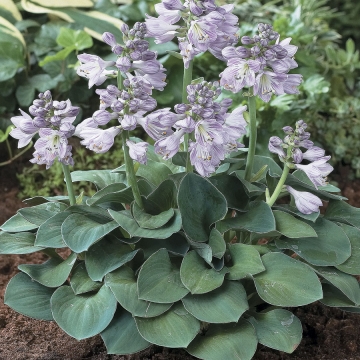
145;0;238;68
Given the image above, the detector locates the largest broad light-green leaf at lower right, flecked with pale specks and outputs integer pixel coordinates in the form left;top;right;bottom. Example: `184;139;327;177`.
254;252;323;306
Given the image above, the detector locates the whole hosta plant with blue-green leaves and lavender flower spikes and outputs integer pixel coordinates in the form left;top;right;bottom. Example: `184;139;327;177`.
0;0;360;360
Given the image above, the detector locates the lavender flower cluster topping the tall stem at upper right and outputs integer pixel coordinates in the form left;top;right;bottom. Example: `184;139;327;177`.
220;24;302;102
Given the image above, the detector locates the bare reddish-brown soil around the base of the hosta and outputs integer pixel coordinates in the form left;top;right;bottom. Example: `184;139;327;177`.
0;148;360;360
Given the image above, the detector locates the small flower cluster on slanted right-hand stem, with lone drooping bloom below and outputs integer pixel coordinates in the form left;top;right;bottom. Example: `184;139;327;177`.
269;120;333;214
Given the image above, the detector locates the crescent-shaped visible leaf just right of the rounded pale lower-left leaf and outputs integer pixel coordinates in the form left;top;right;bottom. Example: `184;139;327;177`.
105;266;172;317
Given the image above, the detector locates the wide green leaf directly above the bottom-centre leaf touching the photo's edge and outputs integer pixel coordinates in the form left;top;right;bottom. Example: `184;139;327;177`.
181;280;249;323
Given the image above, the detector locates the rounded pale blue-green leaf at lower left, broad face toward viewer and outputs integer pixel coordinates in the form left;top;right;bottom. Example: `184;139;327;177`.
51;286;117;340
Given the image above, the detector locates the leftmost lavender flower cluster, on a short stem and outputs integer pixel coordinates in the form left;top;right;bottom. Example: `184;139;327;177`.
10;90;80;169
